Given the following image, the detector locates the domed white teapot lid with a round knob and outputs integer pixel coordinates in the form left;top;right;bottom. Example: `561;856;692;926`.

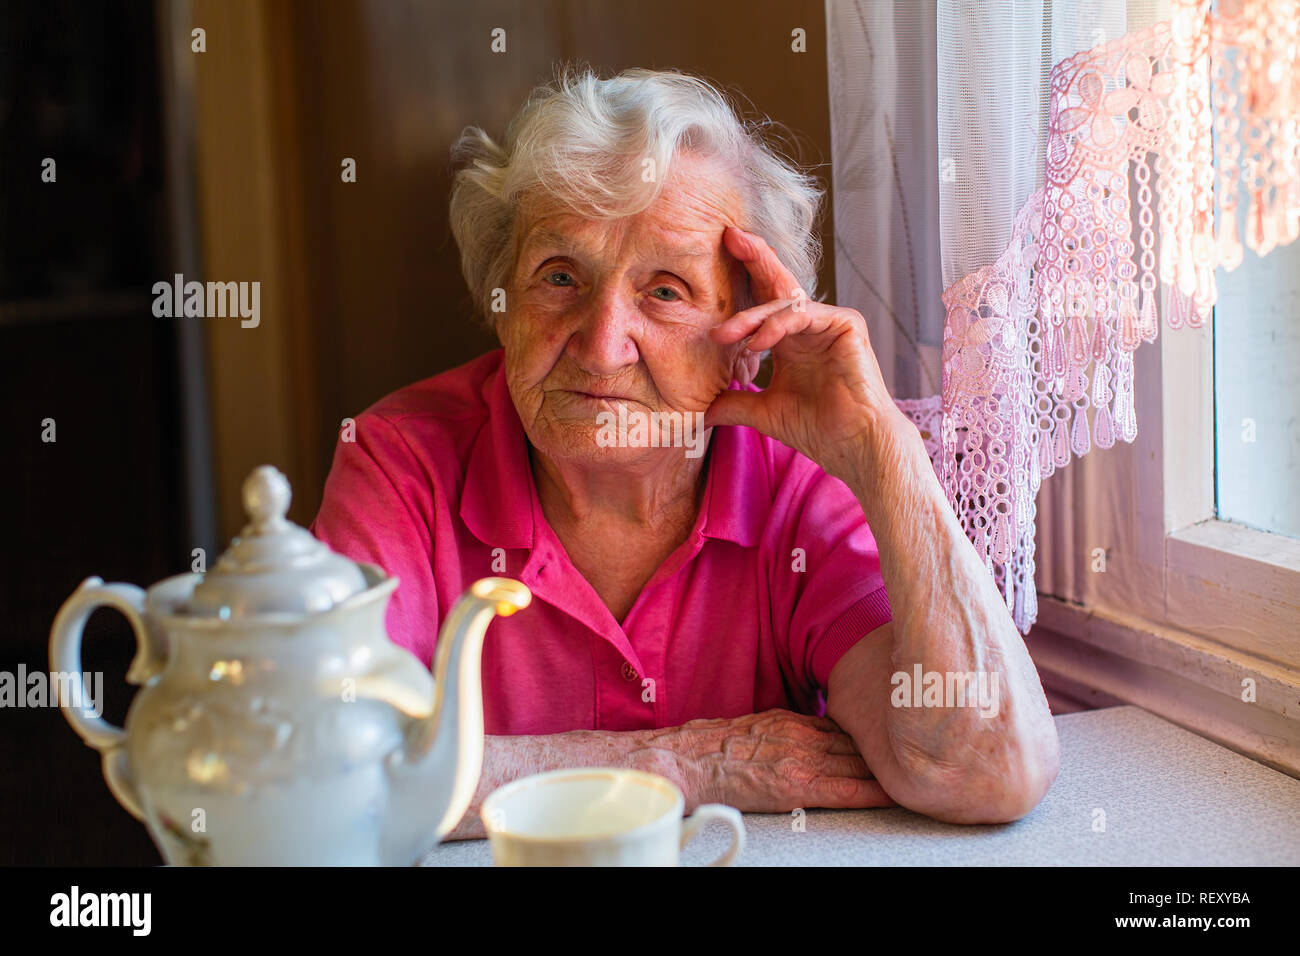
189;464;368;620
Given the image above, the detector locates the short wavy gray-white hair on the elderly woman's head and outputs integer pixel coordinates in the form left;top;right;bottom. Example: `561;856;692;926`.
451;68;823;325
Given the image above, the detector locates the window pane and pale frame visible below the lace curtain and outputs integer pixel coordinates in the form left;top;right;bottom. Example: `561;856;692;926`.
1159;278;1300;670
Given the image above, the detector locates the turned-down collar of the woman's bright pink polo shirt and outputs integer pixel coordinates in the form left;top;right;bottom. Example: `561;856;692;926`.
460;349;771;550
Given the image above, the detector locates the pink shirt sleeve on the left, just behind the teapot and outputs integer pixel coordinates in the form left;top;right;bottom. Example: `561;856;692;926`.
311;415;438;667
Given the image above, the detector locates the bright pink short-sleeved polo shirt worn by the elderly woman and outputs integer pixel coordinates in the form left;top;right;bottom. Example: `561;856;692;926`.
312;349;891;734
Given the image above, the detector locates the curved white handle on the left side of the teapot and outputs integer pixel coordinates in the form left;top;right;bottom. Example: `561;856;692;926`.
49;578;161;819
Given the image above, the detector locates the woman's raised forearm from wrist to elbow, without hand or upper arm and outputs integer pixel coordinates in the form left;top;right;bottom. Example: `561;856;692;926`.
849;415;1060;810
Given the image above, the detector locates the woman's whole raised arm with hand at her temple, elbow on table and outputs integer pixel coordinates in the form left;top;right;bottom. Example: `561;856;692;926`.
705;228;1060;823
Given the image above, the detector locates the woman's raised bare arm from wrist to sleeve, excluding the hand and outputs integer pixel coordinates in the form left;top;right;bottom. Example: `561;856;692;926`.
827;412;1061;823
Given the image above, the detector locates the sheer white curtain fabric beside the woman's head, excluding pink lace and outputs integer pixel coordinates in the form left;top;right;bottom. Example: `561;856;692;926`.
826;0;1169;382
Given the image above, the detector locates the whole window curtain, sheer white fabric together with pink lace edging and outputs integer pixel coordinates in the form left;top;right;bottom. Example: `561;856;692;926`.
827;0;1300;632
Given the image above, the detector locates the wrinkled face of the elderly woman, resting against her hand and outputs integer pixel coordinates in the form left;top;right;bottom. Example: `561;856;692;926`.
498;155;757;466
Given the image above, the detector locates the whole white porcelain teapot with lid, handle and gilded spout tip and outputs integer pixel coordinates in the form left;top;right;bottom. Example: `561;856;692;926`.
49;466;532;866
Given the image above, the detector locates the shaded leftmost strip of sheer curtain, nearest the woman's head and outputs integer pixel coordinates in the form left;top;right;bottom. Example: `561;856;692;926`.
827;0;944;398
